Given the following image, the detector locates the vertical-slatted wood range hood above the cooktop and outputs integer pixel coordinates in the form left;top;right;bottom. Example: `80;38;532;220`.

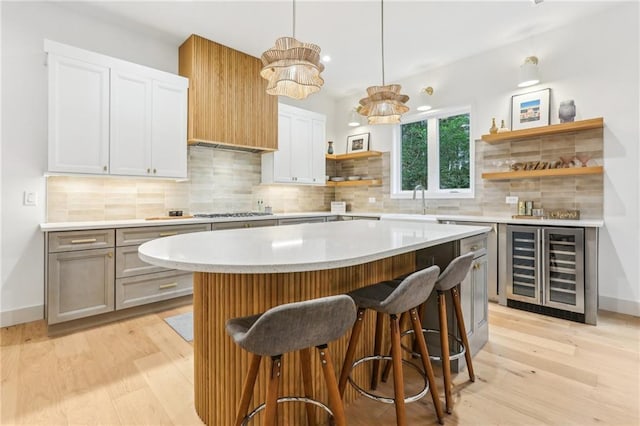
179;35;278;152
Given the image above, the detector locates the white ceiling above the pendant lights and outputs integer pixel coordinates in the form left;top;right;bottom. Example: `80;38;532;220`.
64;0;616;96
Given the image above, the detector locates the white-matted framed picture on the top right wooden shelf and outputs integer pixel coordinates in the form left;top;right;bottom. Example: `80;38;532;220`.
511;89;551;130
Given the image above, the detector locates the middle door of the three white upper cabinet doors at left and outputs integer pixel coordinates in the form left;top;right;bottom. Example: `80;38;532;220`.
109;69;152;176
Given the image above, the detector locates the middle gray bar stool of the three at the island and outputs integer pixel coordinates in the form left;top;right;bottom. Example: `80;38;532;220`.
338;266;443;426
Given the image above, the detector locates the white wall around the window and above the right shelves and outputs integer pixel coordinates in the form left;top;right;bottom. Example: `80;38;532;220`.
336;2;640;316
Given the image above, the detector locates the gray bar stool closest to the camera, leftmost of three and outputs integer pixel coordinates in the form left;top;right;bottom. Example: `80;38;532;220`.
226;295;356;426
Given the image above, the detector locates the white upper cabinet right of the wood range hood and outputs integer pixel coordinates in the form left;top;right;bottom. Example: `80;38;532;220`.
262;104;326;185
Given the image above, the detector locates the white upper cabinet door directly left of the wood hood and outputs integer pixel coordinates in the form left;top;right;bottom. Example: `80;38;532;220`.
151;81;187;178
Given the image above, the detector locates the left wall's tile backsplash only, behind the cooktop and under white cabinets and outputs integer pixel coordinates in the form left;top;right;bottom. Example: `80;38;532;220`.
47;146;333;222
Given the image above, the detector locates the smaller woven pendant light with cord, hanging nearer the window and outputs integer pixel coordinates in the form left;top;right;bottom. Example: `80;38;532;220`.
358;0;409;124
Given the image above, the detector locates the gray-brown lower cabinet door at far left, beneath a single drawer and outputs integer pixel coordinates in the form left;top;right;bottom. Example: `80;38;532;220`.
47;248;114;324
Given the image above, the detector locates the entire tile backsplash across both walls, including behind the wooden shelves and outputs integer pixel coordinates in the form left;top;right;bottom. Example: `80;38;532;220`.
47;129;603;222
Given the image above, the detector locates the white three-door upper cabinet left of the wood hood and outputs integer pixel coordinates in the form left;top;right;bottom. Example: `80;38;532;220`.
45;40;188;178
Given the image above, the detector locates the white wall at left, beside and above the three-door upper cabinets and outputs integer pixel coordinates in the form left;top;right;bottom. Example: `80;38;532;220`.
0;2;180;326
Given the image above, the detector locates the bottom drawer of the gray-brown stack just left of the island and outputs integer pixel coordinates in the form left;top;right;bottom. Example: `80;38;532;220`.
116;271;193;310
